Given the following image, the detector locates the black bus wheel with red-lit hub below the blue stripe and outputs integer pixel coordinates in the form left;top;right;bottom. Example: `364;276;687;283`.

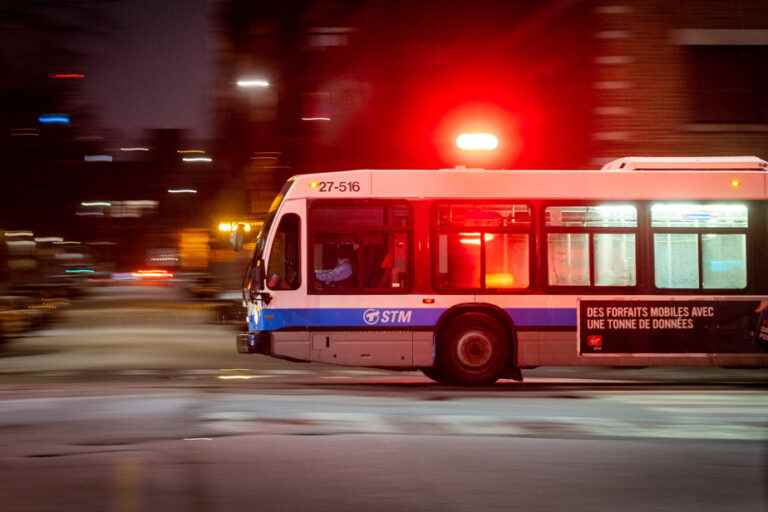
437;313;510;385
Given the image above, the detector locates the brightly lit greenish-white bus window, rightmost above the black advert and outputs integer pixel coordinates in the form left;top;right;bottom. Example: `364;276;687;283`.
651;203;749;289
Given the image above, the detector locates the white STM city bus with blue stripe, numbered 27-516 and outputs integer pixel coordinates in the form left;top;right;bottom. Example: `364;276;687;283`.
237;157;768;385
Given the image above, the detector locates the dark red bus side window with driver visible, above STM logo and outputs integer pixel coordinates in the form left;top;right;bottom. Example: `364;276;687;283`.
310;202;411;293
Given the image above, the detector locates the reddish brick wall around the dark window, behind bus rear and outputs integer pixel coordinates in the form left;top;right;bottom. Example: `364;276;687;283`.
593;0;768;165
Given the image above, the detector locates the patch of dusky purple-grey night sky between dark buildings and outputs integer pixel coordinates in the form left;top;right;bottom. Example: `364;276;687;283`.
85;0;215;139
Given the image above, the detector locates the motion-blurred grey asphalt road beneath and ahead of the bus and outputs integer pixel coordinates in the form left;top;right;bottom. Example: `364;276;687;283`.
0;288;768;511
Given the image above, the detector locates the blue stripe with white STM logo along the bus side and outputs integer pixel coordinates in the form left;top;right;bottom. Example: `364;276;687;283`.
248;308;576;331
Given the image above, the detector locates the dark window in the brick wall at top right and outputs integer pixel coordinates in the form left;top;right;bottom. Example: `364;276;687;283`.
689;45;768;124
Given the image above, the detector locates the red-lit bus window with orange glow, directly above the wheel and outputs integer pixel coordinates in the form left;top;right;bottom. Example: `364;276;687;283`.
435;203;531;290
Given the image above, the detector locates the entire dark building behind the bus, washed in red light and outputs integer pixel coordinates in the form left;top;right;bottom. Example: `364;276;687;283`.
216;0;768;215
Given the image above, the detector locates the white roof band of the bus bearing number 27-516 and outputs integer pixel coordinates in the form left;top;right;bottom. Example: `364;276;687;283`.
286;160;768;201
